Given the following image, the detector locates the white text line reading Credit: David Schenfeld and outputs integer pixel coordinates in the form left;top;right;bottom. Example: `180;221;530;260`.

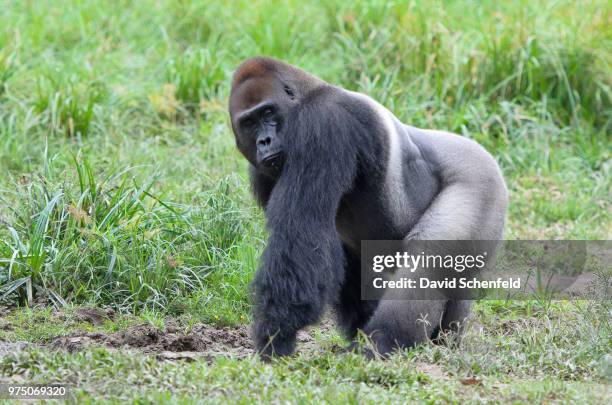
372;277;521;290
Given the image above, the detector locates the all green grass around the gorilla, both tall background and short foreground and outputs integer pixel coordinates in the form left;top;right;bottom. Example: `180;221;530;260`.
0;0;612;403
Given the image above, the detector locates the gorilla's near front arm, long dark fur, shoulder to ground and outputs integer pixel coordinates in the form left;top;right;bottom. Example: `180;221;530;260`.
253;100;357;358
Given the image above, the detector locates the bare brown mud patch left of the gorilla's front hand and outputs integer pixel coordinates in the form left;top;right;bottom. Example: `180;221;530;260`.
48;324;253;360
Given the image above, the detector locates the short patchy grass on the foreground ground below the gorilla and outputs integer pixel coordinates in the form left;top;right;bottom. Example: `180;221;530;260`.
0;301;612;403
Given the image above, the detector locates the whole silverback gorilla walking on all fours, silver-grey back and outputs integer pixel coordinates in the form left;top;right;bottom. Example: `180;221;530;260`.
229;57;508;359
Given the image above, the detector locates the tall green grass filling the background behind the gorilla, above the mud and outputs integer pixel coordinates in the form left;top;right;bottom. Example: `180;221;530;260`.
0;0;612;312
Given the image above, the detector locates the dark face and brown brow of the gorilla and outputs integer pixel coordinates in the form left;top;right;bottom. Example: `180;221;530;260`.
230;76;295;178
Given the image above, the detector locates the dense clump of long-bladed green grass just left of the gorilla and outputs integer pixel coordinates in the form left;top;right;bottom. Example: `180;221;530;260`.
0;157;254;318
